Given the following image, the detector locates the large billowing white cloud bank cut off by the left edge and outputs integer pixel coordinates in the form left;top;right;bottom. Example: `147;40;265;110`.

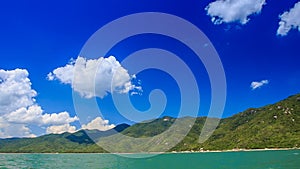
0;69;78;138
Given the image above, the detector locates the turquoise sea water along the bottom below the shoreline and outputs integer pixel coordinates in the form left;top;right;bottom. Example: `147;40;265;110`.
0;150;300;169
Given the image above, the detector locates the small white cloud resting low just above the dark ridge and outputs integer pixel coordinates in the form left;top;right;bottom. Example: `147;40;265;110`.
82;117;115;131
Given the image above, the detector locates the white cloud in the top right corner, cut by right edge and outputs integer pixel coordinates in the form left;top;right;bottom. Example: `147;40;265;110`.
277;1;300;36
